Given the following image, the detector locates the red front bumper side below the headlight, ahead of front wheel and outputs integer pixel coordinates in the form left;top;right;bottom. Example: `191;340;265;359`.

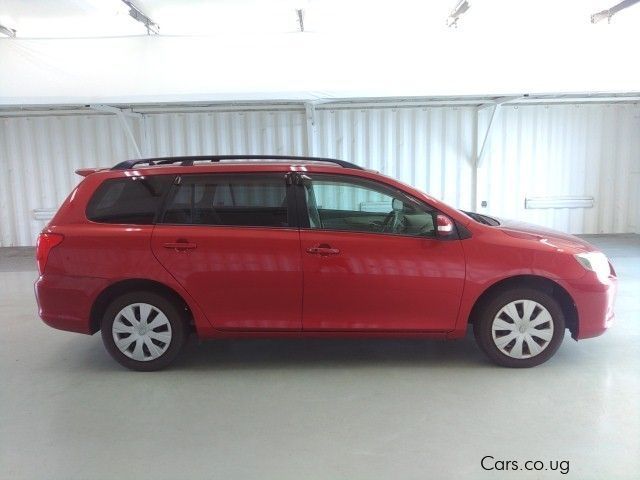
569;274;618;340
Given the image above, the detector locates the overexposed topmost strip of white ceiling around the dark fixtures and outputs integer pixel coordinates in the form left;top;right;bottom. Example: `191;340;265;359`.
0;0;640;41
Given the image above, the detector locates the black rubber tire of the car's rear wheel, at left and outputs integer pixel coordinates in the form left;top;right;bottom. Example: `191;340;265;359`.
101;291;188;372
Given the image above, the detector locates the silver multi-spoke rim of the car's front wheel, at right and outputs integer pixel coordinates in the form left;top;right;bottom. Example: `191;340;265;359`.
491;299;553;359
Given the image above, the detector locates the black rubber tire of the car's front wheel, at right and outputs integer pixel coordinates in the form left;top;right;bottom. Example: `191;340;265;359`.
473;288;565;368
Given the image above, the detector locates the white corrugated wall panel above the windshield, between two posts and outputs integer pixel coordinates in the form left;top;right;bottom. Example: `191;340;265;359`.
316;107;475;208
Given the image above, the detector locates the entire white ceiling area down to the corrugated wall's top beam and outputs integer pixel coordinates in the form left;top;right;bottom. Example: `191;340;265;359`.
0;0;640;105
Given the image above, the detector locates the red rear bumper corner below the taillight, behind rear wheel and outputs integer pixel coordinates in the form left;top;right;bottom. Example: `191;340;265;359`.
35;275;106;334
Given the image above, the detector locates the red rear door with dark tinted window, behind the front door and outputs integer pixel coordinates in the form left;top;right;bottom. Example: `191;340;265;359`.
152;172;302;330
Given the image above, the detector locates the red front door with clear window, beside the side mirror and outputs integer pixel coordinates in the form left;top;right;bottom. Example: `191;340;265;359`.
297;174;465;332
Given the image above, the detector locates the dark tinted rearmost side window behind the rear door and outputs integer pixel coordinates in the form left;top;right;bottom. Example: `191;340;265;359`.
86;175;174;225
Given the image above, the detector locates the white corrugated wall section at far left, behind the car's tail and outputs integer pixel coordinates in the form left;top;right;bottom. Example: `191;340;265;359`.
0;115;135;247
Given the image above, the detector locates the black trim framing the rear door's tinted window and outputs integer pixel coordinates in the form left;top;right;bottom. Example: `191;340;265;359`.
156;171;298;230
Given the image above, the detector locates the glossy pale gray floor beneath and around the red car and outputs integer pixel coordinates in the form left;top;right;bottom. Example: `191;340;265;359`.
0;236;640;480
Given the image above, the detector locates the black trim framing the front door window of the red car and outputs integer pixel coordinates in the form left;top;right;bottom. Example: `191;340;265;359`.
294;172;442;240
